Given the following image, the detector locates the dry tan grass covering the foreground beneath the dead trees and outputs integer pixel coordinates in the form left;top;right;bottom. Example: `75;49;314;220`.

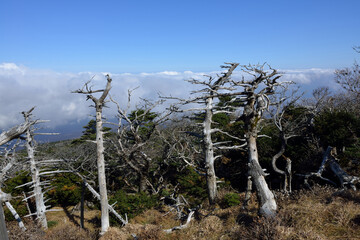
9;187;360;240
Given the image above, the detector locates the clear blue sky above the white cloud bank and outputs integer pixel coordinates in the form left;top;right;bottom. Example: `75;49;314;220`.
0;0;360;73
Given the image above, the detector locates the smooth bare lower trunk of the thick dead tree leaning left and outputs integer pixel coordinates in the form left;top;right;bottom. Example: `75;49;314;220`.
248;136;277;216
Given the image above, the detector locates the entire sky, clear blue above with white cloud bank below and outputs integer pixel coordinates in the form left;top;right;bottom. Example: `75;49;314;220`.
0;0;360;139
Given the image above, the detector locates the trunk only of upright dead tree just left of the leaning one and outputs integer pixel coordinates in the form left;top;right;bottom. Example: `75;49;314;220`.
203;94;217;205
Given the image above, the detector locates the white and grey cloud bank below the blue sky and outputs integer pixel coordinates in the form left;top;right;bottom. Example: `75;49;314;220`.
0;63;337;132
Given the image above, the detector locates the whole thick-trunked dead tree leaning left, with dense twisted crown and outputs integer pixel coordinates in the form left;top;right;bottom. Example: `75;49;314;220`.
234;65;283;216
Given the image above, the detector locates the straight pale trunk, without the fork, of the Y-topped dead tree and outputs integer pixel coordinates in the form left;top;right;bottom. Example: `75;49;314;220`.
96;103;110;234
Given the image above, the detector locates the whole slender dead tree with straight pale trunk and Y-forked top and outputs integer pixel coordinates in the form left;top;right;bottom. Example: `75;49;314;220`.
74;75;112;234
